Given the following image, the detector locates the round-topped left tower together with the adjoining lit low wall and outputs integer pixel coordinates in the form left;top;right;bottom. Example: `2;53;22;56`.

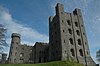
8;33;32;63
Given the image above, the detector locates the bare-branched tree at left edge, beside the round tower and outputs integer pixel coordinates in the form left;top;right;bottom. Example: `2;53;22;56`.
0;24;8;60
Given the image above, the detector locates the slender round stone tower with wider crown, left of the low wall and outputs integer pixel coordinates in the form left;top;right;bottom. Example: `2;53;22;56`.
8;33;21;63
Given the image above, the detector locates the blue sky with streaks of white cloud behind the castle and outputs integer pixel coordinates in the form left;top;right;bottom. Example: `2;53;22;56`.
0;0;100;62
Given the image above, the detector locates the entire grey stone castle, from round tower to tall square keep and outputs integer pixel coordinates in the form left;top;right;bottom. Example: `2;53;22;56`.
8;3;96;66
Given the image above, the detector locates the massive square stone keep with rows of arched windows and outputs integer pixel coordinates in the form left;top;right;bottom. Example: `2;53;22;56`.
49;3;95;65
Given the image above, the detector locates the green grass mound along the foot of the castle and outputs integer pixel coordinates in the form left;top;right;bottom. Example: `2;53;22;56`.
0;61;83;66
